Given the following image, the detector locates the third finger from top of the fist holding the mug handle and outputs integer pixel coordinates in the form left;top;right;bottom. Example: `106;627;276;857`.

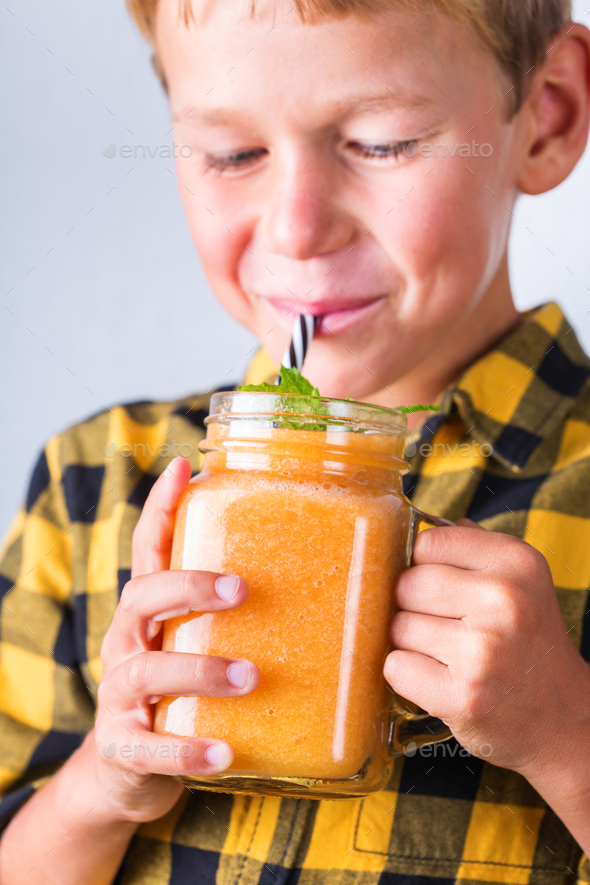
389;612;465;665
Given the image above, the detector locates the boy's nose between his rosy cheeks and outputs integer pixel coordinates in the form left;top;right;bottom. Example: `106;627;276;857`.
261;152;356;261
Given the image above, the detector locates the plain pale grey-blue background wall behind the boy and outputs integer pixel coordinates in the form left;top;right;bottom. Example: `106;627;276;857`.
0;0;590;532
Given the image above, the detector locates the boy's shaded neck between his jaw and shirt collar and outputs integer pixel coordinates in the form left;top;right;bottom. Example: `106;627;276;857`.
366;254;521;430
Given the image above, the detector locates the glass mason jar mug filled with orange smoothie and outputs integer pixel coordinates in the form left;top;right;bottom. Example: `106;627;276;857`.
154;392;452;799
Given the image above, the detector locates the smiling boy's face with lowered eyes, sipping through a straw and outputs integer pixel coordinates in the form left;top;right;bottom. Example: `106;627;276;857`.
157;0;523;396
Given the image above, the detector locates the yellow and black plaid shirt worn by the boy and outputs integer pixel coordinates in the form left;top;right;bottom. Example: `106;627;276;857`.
0;304;590;885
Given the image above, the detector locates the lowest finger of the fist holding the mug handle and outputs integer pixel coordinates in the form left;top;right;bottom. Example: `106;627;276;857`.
383;650;456;720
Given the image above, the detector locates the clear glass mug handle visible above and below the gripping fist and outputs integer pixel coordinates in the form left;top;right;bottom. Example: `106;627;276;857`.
389;507;456;756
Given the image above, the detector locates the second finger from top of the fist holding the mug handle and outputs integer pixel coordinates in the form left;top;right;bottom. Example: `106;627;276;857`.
394;565;478;618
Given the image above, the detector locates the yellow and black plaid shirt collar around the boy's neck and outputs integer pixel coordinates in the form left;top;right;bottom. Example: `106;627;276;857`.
245;302;590;472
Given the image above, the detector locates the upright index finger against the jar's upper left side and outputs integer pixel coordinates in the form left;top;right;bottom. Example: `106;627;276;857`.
131;458;191;577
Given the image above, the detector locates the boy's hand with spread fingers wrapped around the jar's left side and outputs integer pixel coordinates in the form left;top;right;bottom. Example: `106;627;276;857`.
83;458;260;821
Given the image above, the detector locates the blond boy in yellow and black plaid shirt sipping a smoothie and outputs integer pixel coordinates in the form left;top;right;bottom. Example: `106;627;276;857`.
0;0;590;885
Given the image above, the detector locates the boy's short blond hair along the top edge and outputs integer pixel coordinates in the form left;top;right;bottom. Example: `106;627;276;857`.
127;0;572;115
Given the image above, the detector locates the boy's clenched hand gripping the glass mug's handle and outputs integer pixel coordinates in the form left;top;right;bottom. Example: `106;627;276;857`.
384;520;590;782
